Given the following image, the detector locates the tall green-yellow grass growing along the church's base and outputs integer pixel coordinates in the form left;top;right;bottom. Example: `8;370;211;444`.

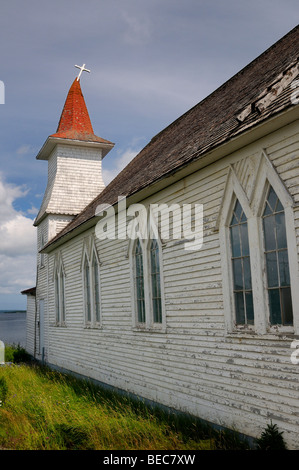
0;348;252;450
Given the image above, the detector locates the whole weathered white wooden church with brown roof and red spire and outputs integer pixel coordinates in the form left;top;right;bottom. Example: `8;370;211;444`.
22;27;299;449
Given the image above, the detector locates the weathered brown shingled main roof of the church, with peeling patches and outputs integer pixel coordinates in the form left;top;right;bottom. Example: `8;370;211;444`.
45;26;299;253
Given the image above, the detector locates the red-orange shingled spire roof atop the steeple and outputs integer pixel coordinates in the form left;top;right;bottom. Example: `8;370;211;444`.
50;78;110;143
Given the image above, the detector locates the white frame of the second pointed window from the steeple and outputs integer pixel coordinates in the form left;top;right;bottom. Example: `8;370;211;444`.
81;237;102;328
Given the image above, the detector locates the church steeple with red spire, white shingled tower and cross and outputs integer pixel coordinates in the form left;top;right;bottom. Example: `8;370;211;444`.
35;66;114;231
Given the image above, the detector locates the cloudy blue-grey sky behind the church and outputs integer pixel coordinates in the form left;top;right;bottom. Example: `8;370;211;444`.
0;0;299;310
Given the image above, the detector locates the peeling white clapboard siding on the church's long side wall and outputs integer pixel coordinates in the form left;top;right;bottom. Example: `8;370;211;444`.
30;119;299;447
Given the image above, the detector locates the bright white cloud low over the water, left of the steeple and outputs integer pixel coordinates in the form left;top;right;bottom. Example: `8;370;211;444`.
0;173;36;294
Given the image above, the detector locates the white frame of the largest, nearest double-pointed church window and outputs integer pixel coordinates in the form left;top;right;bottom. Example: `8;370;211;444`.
217;151;299;335
